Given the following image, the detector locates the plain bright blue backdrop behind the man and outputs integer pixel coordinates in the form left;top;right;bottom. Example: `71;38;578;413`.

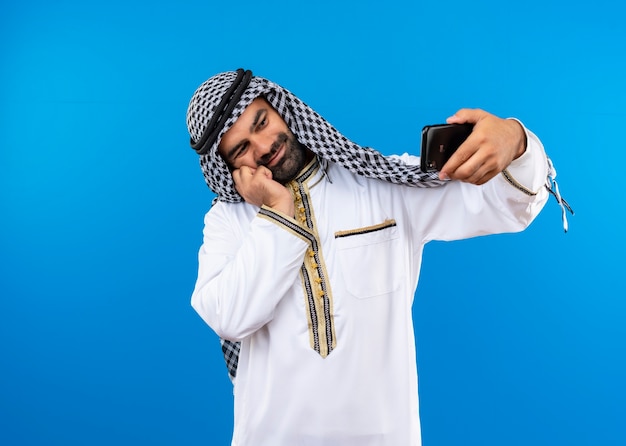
0;0;626;446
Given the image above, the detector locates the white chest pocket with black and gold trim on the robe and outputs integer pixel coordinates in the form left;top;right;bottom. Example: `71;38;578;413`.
335;220;404;299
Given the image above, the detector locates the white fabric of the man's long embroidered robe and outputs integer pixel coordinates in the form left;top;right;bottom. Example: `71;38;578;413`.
192;127;548;446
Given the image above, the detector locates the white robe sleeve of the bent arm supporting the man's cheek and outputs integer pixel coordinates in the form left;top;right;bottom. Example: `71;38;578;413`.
191;203;309;341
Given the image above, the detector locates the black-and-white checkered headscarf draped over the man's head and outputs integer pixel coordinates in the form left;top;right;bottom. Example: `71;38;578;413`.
187;69;444;203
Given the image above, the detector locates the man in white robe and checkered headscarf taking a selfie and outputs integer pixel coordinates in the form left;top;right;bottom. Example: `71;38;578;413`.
187;70;554;446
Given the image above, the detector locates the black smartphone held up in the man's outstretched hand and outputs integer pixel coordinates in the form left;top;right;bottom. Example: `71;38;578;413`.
420;124;474;172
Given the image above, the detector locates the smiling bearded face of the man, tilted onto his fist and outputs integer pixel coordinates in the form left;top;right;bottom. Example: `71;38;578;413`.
218;98;307;184
